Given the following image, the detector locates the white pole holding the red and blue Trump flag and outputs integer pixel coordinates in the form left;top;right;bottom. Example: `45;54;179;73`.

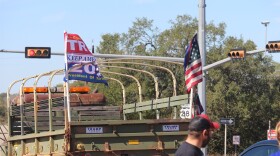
64;31;71;122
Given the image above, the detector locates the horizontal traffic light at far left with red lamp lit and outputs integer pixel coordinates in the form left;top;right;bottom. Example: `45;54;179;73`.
25;47;51;58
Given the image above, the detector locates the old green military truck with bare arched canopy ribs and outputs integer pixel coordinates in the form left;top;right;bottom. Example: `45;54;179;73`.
3;58;189;156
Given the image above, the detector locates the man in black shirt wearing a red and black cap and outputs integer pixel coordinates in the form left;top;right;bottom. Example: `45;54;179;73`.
175;114;220;156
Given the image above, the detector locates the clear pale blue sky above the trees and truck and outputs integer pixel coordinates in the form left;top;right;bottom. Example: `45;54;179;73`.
0;0;280;93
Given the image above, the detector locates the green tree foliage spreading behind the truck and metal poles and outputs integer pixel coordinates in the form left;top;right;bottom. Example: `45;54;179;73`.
0;15;280;154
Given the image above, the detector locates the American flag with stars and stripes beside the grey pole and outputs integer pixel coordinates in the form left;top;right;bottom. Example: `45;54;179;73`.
184;34;202;94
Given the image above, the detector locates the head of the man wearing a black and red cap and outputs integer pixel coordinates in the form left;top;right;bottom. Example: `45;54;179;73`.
188;114;220;147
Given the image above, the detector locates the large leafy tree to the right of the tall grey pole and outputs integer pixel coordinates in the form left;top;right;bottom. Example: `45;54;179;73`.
206;37;279;153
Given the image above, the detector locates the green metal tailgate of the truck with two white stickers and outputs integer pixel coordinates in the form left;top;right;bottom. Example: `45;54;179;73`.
71;119;189;156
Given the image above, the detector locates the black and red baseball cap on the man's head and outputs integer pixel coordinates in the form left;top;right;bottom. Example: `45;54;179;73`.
189;114;220;131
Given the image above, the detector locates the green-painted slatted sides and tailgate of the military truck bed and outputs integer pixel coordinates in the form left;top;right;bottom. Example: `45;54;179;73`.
8;95;189;156
